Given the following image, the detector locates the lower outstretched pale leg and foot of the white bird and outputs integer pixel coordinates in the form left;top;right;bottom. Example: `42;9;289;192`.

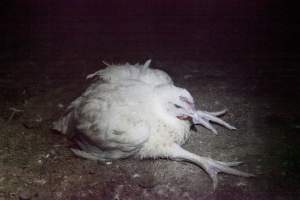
168;144;254;190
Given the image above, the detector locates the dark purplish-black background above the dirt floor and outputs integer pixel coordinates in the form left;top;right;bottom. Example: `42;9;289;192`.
1;0;299;59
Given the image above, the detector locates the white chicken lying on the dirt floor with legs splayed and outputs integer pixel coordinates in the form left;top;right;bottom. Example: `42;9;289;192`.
53;60;253;188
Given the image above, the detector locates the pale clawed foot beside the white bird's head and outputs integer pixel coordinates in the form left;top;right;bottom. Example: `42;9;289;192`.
193;110;236;134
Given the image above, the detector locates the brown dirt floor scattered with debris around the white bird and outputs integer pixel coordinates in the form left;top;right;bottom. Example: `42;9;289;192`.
0;55;300;200
